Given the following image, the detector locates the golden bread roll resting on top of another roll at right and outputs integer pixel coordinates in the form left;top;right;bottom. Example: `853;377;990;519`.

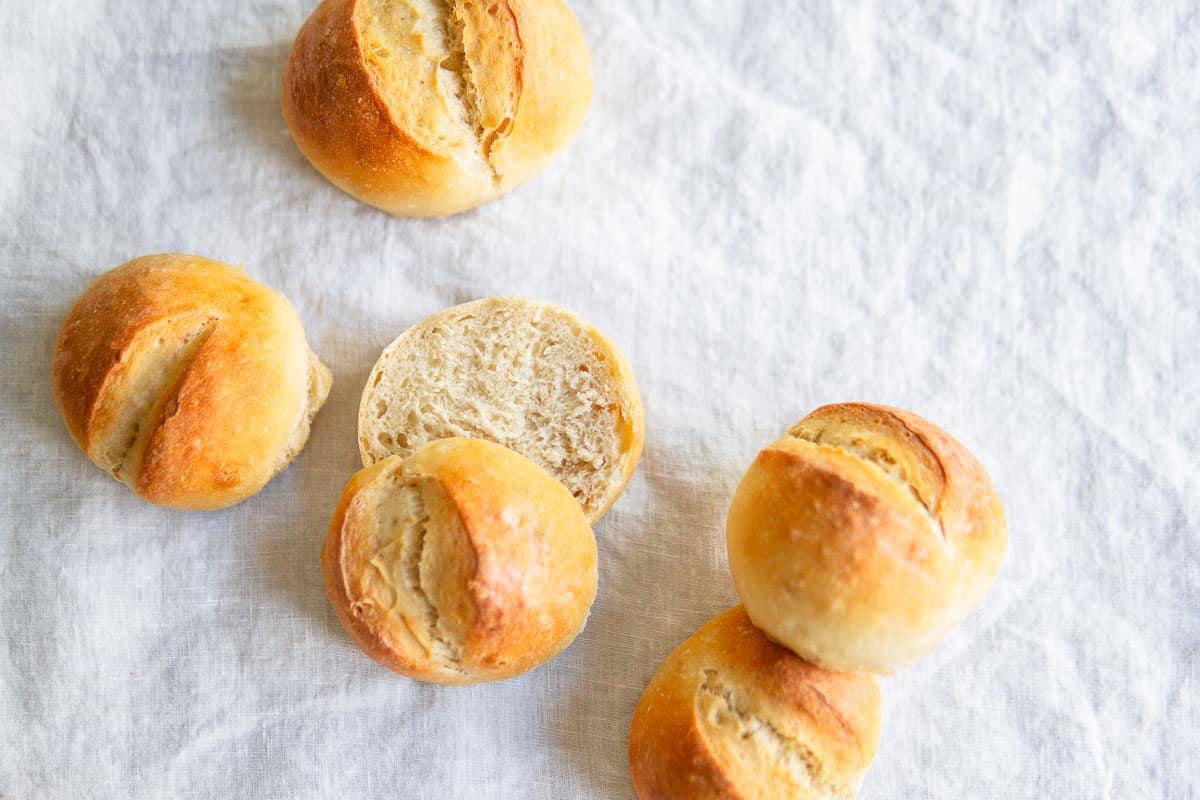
726;403;1008;672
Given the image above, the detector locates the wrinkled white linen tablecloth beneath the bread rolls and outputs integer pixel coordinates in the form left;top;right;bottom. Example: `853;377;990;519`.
0;0;1200;800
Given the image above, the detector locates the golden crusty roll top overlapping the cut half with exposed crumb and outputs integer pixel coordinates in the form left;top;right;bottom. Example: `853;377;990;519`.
320;439;596;684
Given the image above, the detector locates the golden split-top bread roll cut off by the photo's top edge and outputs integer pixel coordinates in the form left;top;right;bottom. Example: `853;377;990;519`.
283;0;592;217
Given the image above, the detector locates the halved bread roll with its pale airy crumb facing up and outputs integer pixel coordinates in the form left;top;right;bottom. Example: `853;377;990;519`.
359;297;644;523
